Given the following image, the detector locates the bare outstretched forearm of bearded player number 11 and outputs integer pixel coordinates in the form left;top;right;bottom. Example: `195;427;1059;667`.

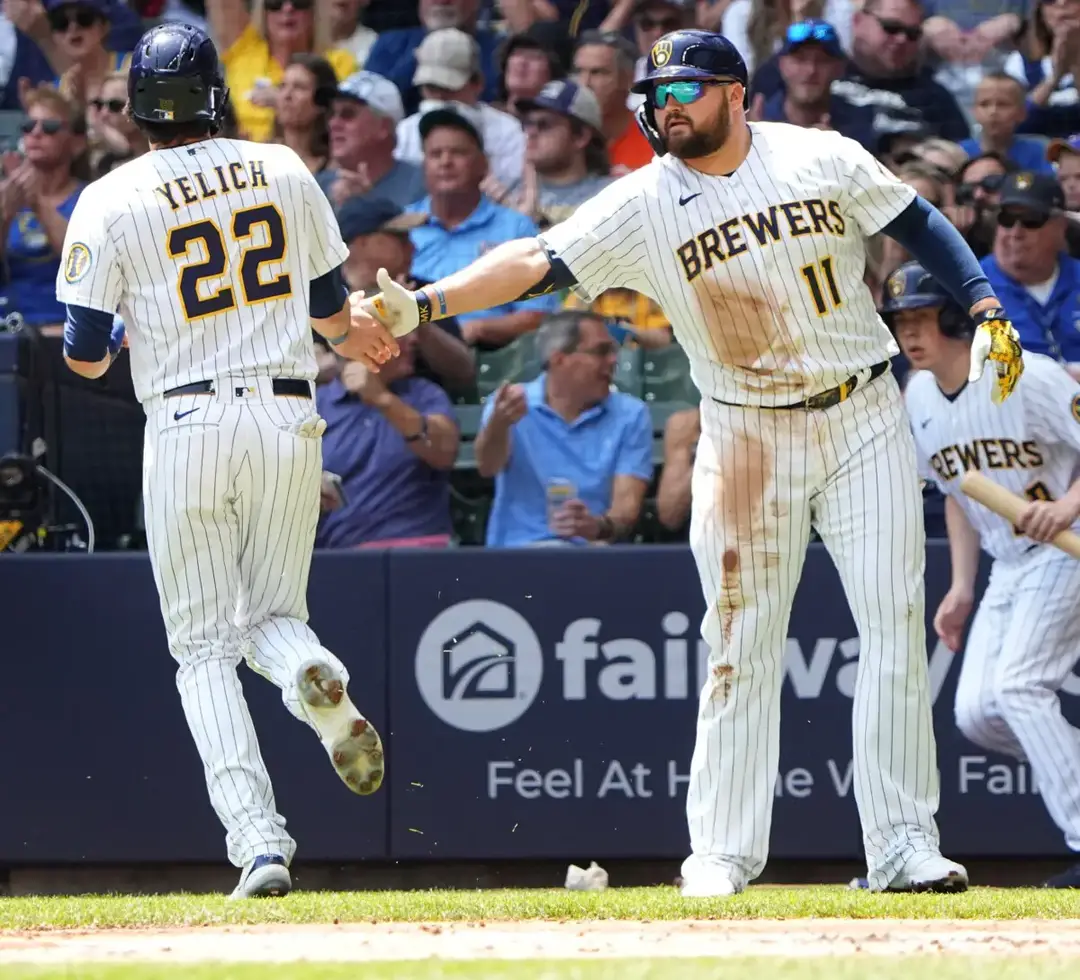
415;238;551;323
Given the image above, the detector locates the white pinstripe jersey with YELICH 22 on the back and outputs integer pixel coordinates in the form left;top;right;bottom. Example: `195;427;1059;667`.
56;139;348;401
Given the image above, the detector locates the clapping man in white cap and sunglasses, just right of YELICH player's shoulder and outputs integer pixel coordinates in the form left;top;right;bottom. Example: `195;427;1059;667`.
315;71;423;216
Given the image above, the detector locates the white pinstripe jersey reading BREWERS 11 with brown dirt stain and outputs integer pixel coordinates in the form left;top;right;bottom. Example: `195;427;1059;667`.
541;123;915;406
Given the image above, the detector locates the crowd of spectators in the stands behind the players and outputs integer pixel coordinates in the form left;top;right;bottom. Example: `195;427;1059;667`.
0;0;1080;548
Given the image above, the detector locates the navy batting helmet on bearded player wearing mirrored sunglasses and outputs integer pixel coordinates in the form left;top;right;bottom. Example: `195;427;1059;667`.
631;30;750;156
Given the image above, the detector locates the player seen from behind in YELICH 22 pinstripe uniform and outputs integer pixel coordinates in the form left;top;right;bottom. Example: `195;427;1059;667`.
56;24;396;898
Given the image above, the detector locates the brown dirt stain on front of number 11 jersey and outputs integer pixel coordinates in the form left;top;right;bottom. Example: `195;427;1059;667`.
692;271;807;401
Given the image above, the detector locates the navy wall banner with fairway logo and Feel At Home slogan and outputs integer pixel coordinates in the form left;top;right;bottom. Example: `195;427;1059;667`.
389;543;1080;859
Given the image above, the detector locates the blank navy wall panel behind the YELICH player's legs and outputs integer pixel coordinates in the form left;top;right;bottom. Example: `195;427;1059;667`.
0;554;389;863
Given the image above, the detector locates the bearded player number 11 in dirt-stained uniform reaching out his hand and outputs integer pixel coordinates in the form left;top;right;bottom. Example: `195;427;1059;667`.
353;30;1023;897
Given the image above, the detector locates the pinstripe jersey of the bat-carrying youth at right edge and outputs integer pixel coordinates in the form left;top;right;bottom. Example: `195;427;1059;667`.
904;351;1080;561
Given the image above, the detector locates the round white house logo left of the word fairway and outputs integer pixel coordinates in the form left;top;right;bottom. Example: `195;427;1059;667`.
416;599;543;731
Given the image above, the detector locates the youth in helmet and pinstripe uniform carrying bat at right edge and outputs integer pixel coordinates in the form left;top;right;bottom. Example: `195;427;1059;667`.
894;263;1080;888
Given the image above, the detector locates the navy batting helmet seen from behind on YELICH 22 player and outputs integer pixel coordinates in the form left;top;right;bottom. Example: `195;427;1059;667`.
127;24;229;132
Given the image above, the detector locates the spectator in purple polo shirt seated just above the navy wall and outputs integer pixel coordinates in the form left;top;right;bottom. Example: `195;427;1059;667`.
315;334;460;548
